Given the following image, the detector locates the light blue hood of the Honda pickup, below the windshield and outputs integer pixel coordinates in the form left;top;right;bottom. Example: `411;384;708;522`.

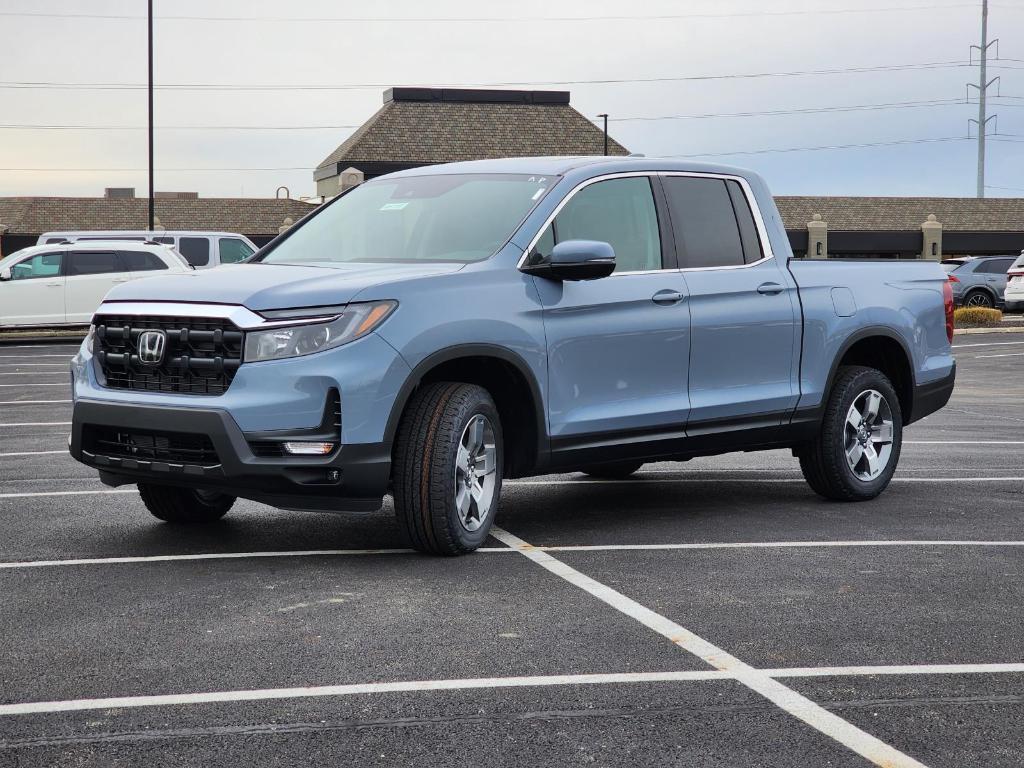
106;263;464;311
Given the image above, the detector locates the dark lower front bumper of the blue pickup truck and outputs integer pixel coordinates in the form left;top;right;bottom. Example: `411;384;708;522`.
70;398;391;512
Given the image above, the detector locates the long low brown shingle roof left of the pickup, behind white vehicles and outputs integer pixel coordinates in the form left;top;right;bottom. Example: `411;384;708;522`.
0;198;315;236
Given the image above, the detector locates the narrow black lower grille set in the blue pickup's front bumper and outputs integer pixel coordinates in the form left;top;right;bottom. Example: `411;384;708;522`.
82;424;220;467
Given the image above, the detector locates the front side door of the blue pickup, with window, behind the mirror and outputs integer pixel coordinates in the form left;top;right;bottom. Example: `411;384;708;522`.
527;175;689;450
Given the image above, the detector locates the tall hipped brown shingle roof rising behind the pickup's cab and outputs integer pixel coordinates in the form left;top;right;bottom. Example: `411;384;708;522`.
316;88;629;178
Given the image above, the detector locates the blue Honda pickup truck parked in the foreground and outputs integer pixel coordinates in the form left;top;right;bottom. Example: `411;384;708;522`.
71;158;955;554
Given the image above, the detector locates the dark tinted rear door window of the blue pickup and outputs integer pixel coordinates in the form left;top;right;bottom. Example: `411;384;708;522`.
664;176;761;268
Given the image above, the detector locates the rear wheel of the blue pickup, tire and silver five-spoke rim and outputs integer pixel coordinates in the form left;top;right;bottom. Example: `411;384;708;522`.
798;366;903;502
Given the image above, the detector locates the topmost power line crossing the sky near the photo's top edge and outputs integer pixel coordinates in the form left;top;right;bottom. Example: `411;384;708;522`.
0;3;976;24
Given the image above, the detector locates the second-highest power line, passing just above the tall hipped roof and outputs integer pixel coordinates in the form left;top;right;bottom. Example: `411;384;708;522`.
0;60;972;91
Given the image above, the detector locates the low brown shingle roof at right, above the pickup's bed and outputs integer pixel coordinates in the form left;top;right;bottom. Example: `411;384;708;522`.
775;197;1024;231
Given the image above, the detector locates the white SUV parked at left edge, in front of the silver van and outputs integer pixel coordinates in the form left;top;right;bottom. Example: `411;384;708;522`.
0;242;193;328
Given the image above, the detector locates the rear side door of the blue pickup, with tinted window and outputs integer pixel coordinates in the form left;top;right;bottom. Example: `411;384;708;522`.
662;173;800;435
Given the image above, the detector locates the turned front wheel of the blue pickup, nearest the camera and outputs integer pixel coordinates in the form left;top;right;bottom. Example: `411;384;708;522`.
391;382;504;555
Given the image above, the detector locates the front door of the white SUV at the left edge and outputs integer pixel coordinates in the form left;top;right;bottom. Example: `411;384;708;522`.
0;251;66;326
